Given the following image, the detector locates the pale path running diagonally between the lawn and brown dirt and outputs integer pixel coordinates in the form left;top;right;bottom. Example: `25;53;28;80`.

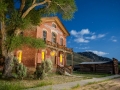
27;75;120;90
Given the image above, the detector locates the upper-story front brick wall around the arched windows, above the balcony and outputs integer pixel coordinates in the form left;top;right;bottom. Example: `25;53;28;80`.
37;22;66;46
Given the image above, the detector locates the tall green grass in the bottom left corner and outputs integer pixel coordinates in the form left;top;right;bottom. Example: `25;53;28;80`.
0;82;22;90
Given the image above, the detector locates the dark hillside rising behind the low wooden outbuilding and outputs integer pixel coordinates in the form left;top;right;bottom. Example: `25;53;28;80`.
67;52;111;65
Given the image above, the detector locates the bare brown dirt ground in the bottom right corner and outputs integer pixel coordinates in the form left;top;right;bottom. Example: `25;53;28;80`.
74;78;120;90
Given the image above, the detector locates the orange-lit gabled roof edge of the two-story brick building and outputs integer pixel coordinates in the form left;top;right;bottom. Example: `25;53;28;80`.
41;16;70;36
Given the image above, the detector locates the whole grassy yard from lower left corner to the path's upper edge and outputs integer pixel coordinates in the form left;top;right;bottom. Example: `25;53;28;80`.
0;73;83;90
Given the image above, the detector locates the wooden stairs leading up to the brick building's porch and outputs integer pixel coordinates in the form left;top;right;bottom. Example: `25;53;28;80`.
57;65;72;75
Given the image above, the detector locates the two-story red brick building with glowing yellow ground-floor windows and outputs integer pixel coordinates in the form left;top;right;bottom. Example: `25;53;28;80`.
16;17;72;73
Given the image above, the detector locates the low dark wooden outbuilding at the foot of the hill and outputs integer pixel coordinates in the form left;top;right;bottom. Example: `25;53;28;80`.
79;58;119;74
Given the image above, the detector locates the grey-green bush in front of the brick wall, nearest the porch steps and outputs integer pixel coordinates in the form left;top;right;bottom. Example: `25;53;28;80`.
35;59;53;79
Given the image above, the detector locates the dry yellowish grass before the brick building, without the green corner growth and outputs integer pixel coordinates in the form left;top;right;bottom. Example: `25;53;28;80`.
0;74;85;88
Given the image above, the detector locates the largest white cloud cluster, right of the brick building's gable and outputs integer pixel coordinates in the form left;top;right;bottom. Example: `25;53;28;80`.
70;29;105;43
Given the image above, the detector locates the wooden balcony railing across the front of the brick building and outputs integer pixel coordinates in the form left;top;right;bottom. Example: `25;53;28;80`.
45;41;73;52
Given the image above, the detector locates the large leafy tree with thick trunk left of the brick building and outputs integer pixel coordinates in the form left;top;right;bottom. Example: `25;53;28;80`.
0;0;76;77
